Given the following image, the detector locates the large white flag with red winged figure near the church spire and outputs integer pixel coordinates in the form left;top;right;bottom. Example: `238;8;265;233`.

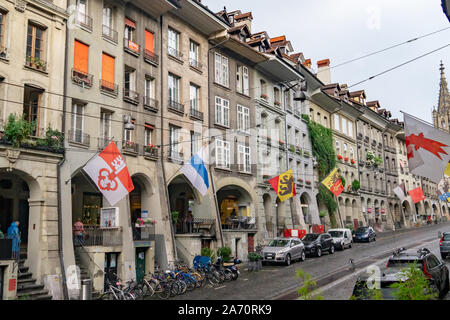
404;113;450;183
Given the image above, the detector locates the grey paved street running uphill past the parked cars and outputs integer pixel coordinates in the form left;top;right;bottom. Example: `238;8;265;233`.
169;223;450;300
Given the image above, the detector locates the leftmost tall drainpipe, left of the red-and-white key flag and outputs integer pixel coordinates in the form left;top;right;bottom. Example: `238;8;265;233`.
57;8;69;300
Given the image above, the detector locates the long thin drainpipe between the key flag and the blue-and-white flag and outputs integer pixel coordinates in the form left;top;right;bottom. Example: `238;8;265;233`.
159;15;178;259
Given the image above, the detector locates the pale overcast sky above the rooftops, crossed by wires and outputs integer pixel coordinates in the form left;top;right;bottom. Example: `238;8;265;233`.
203;0;450;122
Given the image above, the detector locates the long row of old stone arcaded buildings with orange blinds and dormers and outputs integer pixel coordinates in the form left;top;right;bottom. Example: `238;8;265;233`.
0;0;448;299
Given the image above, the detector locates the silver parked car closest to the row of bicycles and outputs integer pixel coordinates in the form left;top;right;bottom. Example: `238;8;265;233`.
262;238;306;266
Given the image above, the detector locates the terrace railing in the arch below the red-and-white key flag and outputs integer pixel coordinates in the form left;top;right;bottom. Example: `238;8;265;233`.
74;226;122;247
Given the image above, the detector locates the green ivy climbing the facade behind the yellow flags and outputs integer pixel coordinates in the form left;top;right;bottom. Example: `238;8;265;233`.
302;114;337;227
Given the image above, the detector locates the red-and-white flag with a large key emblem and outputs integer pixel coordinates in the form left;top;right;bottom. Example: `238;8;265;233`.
83;142;134;206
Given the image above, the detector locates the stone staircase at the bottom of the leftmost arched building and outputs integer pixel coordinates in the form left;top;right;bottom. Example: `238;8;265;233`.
17;255;52;300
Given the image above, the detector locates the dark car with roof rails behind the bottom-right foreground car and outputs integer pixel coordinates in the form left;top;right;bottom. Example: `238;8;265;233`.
383;248;449;298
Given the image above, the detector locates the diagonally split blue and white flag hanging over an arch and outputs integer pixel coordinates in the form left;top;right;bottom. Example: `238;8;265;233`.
180;148;209;196
